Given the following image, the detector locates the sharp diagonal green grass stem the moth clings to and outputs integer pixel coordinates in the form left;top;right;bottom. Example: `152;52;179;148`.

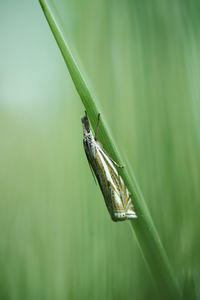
39;0;181;300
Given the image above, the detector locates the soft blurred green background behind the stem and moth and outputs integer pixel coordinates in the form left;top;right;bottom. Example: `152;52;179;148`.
0;0;200;300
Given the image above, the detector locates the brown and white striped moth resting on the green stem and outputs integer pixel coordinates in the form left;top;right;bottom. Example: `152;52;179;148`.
81;112;137;221
